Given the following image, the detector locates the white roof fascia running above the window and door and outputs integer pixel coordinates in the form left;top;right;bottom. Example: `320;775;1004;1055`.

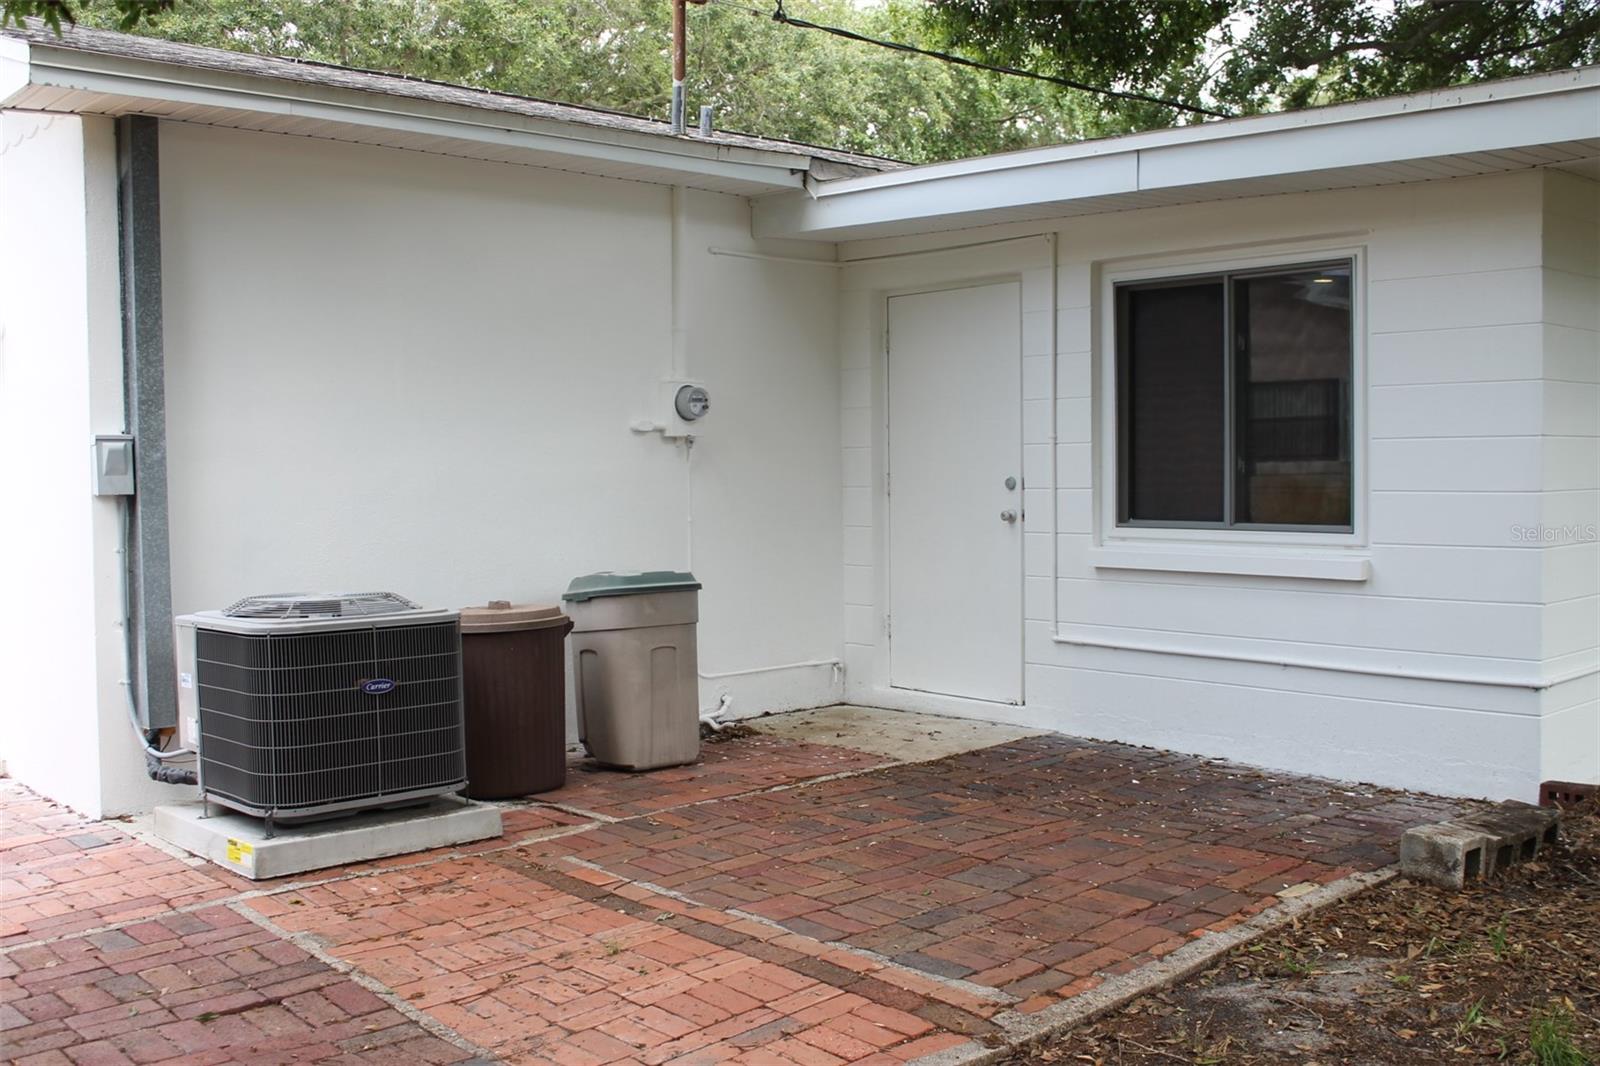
755;67;1600;240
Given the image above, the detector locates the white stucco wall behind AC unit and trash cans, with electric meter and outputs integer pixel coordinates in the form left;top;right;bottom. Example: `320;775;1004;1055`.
0;115;842;815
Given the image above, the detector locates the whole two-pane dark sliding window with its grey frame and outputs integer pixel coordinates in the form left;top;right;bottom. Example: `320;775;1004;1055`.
1115;261;1352;530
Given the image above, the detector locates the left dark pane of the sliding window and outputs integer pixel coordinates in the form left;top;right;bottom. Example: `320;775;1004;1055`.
1118;279;1227;522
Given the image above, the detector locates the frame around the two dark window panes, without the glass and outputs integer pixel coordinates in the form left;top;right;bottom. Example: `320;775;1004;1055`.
1096;245;1366;547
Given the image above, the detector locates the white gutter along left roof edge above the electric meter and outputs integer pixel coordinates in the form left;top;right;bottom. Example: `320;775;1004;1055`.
9;38;808;192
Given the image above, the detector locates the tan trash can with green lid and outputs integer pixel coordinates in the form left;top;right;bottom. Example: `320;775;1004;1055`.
562;570;701;770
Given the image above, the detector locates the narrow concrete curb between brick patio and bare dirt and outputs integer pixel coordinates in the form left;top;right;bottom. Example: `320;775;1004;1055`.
910;866;1400;1066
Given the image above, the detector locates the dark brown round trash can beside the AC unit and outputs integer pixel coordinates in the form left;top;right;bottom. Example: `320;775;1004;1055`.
461;600;573;799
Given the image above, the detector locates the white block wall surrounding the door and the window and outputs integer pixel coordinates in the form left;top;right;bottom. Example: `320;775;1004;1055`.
840;173;1600;799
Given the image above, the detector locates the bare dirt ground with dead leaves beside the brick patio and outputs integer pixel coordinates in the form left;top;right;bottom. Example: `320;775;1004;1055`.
1011;800;1600;1066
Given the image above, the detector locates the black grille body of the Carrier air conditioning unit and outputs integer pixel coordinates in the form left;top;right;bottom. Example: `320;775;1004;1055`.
195;619;466;816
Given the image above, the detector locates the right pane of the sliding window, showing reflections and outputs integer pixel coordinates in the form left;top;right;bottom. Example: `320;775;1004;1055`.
1234;267;1350;527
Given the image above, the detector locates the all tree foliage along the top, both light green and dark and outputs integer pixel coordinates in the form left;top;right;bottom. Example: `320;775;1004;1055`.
9;0;1600;162
